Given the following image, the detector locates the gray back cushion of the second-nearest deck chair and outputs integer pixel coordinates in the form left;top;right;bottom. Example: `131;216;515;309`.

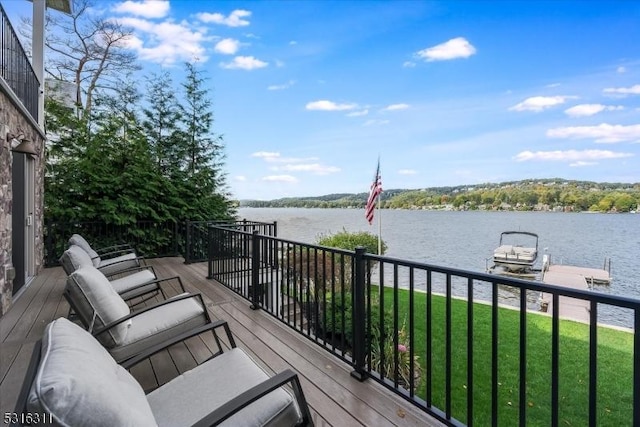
66;266;131;348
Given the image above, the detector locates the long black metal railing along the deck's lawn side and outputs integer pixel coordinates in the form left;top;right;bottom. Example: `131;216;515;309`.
208;226;640;426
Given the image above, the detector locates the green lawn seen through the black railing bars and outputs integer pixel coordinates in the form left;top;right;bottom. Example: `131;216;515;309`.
372;288;633;426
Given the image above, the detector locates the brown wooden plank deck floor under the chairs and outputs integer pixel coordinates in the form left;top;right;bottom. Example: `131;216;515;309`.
0;258;442;426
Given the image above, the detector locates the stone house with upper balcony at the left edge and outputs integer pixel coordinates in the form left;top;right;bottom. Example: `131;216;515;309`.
0;0;72;316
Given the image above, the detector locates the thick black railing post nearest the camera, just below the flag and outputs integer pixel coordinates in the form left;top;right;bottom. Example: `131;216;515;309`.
351;246;368;381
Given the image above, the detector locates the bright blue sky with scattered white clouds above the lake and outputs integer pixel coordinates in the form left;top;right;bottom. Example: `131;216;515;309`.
3;0;640;200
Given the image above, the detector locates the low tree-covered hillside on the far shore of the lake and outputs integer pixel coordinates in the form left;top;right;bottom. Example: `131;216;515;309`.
240;178;640;212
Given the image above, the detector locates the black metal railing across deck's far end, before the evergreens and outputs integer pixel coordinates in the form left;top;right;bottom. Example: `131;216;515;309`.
44;220;277;267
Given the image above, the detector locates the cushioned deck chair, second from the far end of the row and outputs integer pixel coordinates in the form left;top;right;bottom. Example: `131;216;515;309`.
60;245;184;304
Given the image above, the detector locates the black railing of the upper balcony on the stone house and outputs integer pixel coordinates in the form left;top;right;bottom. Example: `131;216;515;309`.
0;4;40;122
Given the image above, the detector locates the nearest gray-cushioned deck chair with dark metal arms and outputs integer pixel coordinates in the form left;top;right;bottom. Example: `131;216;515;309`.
16;318;313;427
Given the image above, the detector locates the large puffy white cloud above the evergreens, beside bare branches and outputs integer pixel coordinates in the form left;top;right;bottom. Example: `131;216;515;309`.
117;17;208;65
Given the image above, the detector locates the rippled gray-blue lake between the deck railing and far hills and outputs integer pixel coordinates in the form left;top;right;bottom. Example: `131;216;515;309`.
238;208;640;326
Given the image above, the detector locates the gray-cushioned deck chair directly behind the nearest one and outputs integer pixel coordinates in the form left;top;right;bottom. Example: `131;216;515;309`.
63;266;211;362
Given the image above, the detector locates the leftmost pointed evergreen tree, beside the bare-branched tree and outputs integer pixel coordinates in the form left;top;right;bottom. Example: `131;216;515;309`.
79;76;170;225
